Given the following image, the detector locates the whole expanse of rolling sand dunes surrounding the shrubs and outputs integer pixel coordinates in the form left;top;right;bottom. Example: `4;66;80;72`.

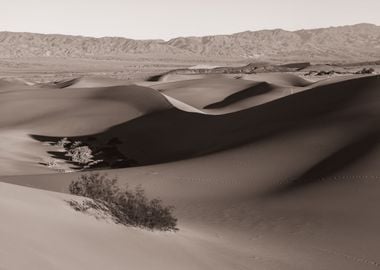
0;73;380;270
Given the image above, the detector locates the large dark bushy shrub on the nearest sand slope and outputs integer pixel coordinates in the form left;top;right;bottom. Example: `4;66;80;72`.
69;173;177;231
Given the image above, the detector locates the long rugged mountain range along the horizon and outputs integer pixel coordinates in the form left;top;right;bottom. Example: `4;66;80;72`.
0;24;380;62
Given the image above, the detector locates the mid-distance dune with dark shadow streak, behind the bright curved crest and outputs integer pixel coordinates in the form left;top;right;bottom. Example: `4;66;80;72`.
151;75;291;114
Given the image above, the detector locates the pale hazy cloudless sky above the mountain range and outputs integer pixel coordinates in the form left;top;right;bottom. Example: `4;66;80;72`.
0;0;380;39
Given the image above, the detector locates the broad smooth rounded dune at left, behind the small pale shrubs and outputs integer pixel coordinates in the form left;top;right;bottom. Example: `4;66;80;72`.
0;83;172;136
